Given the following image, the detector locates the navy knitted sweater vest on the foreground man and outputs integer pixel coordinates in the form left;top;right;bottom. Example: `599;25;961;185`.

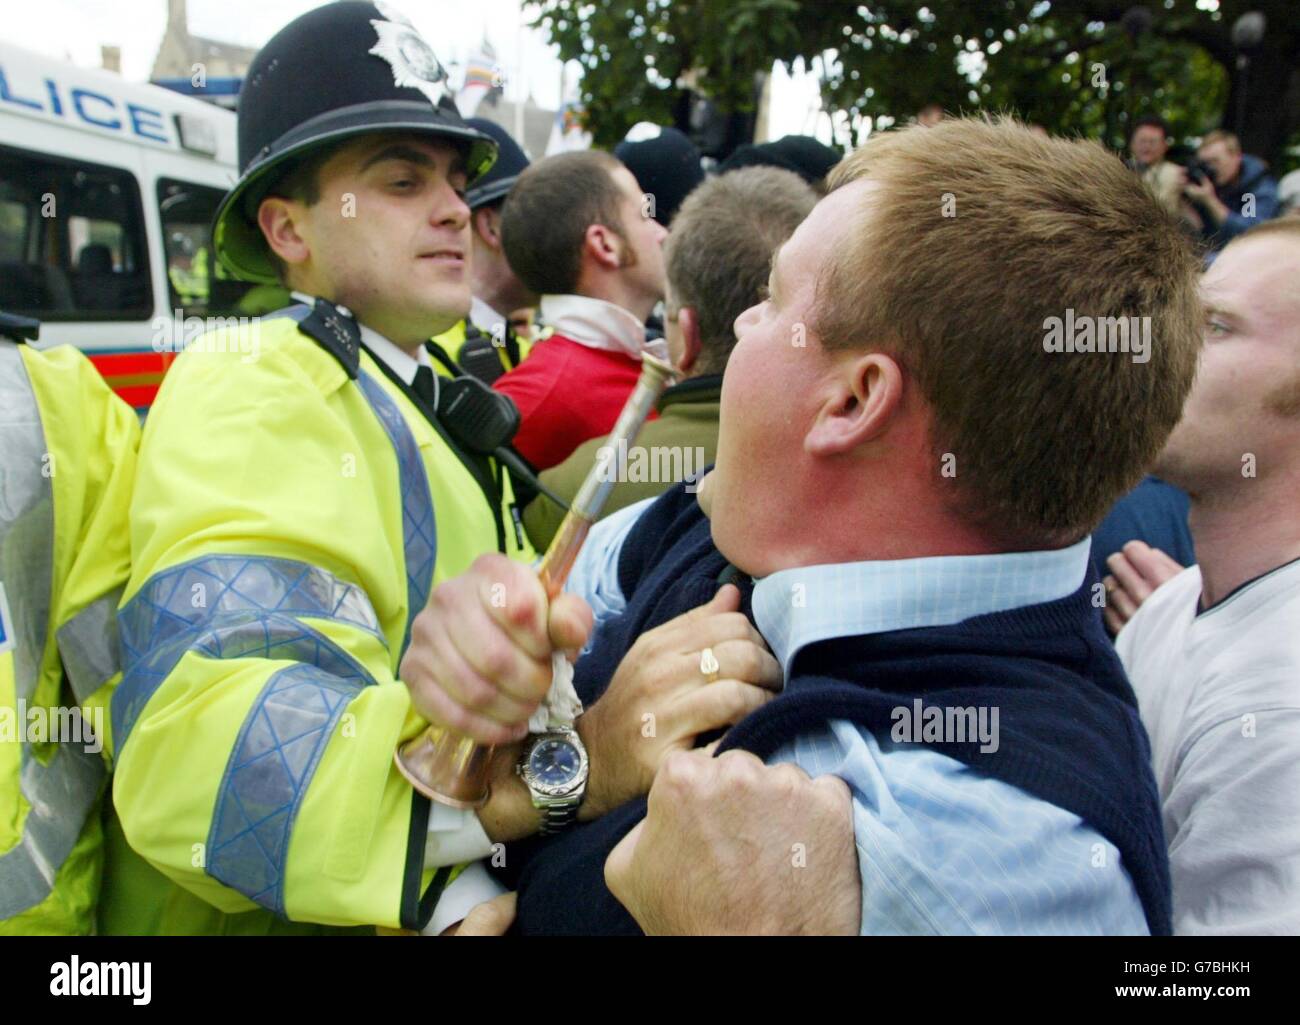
503;486;1170;935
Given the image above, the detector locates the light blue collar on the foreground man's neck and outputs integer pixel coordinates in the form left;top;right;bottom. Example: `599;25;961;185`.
753;537;1092;674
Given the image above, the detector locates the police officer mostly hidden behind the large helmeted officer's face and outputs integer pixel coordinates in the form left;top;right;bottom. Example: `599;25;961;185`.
430;117;537;384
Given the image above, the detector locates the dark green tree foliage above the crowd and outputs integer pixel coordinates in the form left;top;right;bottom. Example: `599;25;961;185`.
530;0;1300;161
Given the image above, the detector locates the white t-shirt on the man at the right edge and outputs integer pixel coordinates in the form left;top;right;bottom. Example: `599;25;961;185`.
1115;562;1300;935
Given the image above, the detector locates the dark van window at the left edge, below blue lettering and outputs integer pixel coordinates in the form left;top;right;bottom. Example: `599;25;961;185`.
0;146;153;320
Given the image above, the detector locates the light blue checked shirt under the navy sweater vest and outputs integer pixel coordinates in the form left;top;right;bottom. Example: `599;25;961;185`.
569;499;1148;935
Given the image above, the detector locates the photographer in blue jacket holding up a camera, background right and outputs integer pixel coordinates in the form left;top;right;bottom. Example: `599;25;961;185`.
1183;131;1278;251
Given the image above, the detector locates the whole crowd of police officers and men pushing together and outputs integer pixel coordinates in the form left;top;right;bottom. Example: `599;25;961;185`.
0;3;1300;935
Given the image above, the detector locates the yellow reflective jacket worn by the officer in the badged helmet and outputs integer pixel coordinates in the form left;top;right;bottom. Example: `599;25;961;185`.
113;303;534;931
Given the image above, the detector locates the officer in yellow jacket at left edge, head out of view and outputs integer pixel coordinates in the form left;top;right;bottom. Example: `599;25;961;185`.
0;313;140;934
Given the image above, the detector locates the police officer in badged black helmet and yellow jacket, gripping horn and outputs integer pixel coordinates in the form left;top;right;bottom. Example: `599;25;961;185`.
111;0;586;933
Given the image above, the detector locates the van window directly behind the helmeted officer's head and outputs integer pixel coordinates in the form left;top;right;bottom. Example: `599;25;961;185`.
157;178;290;316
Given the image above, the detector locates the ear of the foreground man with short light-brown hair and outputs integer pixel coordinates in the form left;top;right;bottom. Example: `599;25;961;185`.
803;353;902;455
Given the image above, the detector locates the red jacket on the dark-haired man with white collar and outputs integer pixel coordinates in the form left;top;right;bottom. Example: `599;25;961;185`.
493;334;655;471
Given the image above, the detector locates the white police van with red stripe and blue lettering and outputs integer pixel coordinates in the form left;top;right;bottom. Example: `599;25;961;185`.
0;44;285;411
